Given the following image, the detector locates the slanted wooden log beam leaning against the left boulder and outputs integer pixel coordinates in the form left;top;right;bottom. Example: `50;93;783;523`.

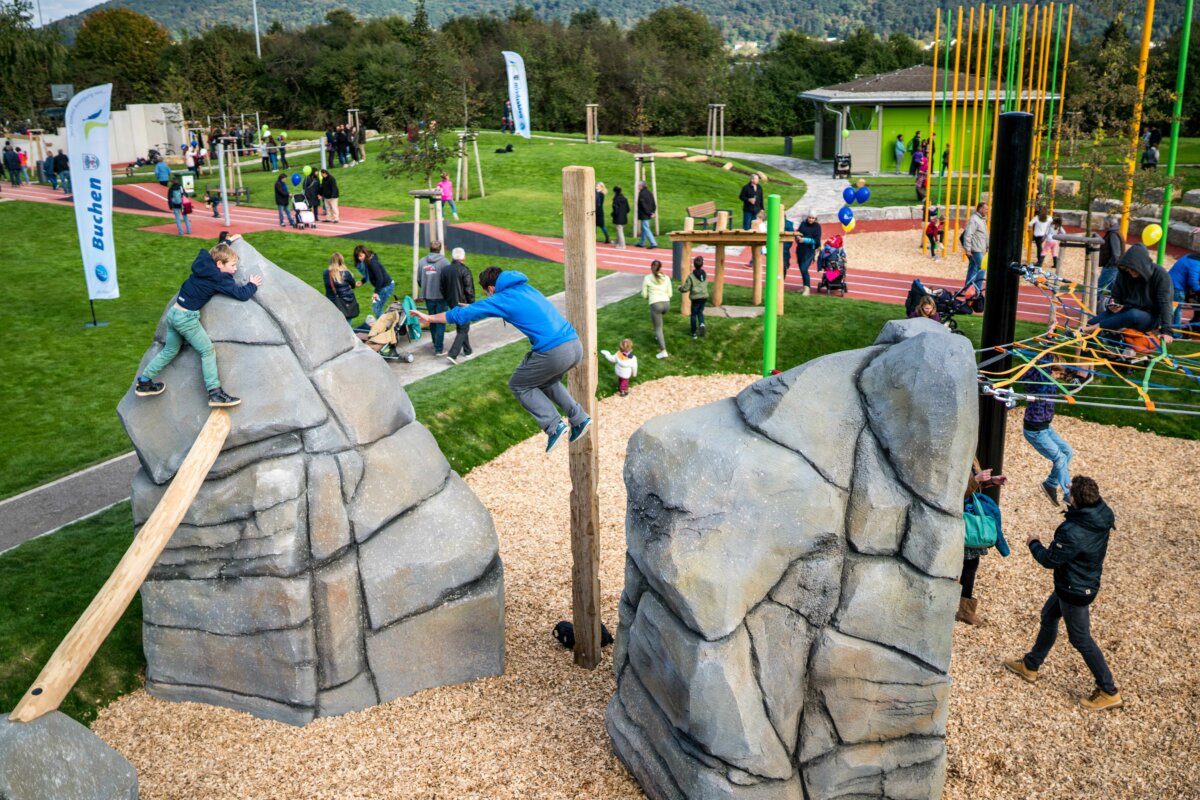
8;417;230;722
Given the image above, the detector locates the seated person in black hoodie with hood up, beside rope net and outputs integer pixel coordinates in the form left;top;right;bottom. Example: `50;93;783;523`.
1080;243;1175;344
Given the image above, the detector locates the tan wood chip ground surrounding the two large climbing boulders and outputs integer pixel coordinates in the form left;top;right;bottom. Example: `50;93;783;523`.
92;376;1200;800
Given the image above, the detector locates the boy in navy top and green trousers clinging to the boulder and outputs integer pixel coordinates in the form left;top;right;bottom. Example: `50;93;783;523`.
133;236;263;408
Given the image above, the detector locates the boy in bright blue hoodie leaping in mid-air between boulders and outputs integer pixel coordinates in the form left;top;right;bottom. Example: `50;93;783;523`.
415;266;592;452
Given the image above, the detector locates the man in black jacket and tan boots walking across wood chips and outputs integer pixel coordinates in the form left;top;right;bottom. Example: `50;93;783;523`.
1004;475;1123;711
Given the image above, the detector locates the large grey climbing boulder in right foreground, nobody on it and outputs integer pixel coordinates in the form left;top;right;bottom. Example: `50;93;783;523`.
607;320;978;800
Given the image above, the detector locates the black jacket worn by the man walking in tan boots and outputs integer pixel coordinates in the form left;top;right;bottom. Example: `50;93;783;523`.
1030;500;1116;606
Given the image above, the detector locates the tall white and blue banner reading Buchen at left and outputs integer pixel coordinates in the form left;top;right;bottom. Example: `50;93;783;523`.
66;84;121;300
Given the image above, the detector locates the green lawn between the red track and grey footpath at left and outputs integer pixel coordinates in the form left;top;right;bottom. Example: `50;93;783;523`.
0;201;576;498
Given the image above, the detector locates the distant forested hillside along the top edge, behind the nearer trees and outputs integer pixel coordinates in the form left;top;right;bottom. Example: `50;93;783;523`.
49;0;1184;43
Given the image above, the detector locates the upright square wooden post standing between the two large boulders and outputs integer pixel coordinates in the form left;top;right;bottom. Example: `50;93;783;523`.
563;167;600;669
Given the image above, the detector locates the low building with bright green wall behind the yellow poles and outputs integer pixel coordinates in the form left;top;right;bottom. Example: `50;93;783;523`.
800;66;1051;174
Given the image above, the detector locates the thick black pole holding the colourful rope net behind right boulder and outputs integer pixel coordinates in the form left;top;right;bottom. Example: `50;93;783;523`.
976;112;1033;500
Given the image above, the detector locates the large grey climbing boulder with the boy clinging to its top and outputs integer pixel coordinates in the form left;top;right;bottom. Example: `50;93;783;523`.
118;237;504;724
